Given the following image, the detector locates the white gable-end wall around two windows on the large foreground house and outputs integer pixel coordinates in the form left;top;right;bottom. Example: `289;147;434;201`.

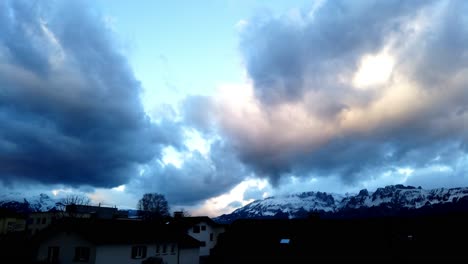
36;232;96;264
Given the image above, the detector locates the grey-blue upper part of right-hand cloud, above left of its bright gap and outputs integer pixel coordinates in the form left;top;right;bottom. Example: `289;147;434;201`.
241;1;428;104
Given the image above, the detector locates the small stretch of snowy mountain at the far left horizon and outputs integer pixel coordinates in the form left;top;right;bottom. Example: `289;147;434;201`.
0;193;58;213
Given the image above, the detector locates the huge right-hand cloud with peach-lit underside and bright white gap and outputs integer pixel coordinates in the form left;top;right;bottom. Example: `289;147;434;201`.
207;1;468;185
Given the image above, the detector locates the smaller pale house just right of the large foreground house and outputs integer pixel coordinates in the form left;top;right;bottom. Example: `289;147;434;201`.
173;212;225;257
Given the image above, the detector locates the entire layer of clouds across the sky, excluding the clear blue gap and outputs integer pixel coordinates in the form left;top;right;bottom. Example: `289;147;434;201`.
0;0;468;210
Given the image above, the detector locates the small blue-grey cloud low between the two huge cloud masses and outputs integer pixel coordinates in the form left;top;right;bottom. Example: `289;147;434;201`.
129;141;246;205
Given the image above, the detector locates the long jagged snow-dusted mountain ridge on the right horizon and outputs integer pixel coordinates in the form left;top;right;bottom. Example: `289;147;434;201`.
215;185;468;223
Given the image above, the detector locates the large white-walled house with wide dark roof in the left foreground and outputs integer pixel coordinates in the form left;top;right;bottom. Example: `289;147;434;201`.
35;219;200;264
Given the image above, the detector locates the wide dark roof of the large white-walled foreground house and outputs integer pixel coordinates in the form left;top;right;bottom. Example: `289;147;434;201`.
39;219;200;248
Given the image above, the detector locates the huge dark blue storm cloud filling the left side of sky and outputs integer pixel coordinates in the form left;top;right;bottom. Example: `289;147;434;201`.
0;0;181;187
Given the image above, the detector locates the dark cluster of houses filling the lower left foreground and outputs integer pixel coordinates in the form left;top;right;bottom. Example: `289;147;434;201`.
0;207;224;264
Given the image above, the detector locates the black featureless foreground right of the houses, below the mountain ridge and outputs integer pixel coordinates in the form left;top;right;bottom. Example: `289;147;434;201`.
212;213;468;264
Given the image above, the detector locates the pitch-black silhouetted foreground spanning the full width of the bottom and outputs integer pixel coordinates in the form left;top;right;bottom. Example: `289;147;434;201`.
0;210;468;264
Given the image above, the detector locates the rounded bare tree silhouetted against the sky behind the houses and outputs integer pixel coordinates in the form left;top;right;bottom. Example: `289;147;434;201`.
137;193;170;219
